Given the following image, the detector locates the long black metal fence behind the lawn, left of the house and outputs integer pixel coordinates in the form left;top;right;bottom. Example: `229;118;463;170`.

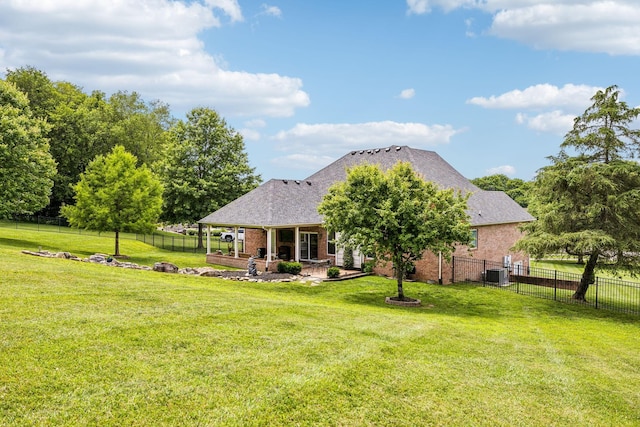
0;215;244;254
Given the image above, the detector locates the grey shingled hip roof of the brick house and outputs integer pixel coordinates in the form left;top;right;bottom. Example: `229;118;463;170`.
199;146;534;228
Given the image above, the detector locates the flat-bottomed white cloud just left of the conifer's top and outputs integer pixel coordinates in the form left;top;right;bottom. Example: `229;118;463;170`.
467;84;604;109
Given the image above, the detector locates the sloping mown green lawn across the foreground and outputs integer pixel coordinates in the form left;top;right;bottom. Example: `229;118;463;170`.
0;228;640;426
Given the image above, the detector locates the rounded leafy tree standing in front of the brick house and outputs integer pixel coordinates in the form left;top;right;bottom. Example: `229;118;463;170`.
318;162;471;300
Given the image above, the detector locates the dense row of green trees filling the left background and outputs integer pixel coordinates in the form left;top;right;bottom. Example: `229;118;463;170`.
0;66;261;254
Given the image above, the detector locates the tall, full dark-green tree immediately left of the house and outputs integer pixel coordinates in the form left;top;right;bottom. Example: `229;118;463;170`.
158;108;260;247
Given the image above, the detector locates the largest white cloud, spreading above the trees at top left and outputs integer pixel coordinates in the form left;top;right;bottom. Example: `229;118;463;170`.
0;0;309;117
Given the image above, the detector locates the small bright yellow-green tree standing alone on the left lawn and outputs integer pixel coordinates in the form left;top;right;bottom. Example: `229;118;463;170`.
62;146;162;256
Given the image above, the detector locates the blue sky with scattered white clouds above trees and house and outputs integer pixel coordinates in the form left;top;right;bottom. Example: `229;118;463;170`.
0;0;640;181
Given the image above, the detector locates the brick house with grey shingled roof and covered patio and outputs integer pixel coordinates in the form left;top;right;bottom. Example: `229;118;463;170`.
199;146;534;283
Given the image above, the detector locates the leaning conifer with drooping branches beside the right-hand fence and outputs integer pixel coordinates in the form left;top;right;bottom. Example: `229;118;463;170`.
516;86;640;301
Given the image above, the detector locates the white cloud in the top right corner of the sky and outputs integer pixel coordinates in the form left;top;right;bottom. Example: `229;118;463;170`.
407;0;640;55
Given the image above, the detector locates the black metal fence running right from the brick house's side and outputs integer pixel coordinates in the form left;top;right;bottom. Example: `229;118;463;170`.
452;257;640;314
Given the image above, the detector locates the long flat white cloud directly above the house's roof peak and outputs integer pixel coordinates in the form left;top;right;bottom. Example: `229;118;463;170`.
272;121;464;160
